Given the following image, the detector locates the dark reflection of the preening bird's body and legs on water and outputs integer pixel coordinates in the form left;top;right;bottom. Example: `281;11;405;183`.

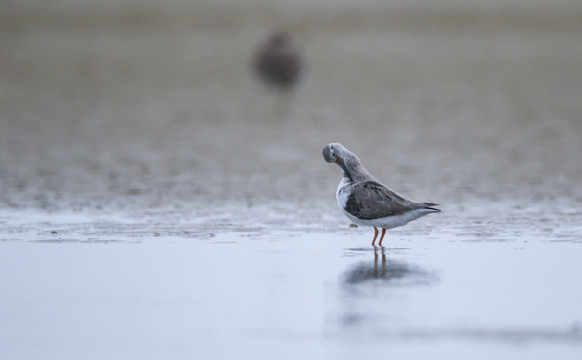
345;247;436;286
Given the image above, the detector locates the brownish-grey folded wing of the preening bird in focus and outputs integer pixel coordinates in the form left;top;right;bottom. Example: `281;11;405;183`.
345;181;423;220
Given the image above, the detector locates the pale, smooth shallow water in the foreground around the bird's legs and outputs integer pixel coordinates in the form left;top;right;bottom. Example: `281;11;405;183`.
0;224;582;359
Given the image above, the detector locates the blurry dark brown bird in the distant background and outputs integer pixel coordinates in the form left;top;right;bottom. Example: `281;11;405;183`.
253;31;303;89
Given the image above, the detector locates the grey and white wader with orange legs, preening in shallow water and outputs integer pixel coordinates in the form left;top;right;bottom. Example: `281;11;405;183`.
322;143;441;246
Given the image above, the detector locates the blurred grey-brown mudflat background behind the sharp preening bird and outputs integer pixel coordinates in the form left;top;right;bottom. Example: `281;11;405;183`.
0;0;582;223
